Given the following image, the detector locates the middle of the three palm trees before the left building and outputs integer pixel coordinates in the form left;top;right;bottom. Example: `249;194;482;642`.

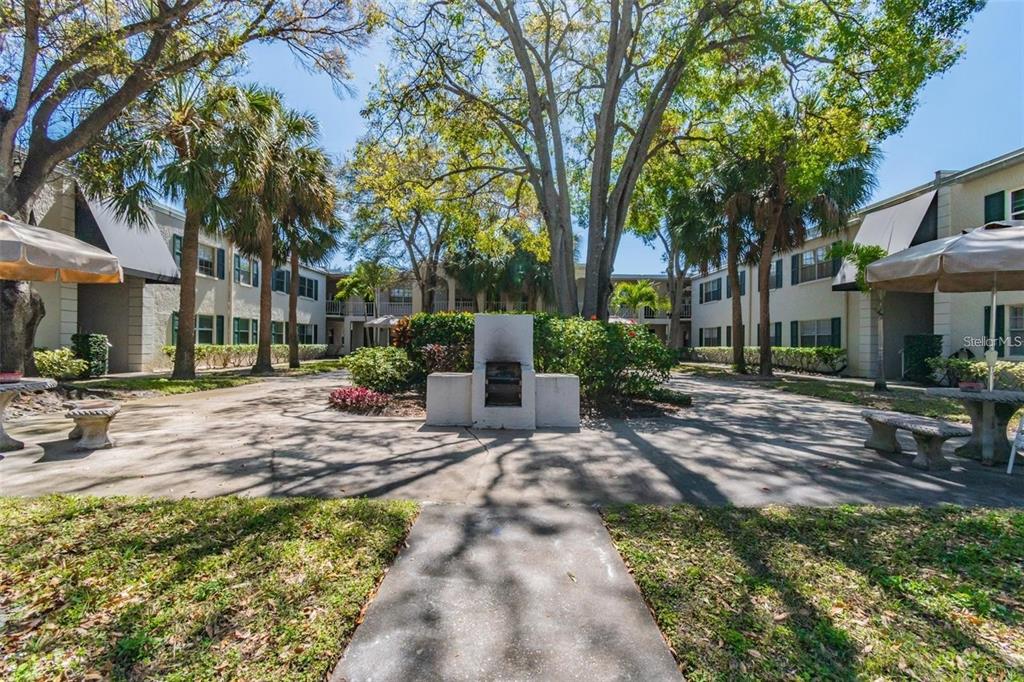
230;102;317;374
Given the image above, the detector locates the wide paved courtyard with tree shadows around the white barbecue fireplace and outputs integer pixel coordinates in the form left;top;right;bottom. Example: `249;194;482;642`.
0;374;1024;506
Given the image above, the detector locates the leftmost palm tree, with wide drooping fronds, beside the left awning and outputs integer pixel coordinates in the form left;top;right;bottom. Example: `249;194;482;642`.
76;76;253;379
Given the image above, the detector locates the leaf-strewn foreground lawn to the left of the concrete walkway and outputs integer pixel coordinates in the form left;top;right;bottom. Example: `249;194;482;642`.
0;497;417;681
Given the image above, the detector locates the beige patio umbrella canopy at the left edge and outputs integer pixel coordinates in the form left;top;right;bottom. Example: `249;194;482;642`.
0;212;124;284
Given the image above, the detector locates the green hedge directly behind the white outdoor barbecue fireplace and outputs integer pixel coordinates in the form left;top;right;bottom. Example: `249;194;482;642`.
397;312;674;402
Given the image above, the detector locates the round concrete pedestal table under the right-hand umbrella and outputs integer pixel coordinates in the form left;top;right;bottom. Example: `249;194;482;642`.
926;388;1024;466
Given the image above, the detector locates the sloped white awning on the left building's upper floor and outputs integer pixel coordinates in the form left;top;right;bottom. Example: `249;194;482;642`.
75;199;180;283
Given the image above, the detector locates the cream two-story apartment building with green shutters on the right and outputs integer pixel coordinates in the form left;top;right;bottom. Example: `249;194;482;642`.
692;150;1024;377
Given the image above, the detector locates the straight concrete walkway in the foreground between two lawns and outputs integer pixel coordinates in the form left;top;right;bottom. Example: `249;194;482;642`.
333;505;682;682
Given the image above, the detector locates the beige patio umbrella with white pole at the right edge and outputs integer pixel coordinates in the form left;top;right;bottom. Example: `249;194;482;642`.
867;220;1024;390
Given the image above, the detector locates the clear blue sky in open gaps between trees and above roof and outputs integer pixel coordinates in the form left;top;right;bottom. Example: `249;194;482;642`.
241;0;1024;273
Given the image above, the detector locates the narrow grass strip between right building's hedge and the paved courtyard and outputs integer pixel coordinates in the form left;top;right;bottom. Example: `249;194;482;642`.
676;363;971;422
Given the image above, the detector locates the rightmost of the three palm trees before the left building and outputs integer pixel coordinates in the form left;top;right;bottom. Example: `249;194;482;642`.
281;146;341;368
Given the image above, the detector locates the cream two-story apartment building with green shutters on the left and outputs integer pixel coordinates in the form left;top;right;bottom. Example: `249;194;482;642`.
32;176;330;372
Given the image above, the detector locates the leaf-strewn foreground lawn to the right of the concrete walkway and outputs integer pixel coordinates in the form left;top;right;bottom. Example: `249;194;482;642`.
604;506;1024;680
